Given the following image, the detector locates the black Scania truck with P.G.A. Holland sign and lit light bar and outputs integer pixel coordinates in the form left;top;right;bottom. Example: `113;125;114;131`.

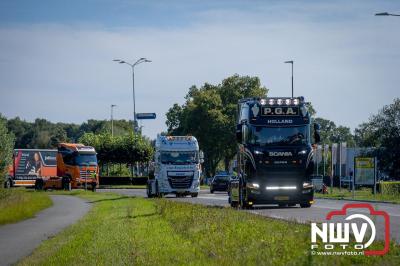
229;97;320;208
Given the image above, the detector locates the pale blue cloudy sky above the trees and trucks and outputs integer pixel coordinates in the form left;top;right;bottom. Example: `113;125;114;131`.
0;0;400;138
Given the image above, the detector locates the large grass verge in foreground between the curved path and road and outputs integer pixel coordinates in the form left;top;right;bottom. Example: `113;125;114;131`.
20;191;400;265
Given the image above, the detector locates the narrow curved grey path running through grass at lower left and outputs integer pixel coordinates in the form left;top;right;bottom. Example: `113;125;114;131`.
0;195;90;265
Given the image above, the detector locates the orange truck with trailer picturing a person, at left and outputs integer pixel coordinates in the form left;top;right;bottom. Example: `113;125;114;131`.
6;143;99;191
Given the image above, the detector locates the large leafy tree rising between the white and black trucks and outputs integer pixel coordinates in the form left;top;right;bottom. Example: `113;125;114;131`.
166;75;268;176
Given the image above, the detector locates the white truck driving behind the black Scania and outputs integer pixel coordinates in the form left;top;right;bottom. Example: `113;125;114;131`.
147;135;203;198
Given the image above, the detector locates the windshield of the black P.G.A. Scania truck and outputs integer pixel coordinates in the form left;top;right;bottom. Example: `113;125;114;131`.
248;125;310;146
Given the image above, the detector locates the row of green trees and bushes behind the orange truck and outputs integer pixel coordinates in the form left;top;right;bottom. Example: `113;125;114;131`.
0;114;153;180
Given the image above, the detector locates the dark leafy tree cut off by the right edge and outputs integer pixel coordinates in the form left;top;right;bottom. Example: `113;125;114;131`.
356;98;400;179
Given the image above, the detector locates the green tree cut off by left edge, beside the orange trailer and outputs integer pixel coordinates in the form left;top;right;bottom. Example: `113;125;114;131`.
0;114;14;189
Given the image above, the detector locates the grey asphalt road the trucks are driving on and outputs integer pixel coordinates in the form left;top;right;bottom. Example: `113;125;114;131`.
98;189;400;243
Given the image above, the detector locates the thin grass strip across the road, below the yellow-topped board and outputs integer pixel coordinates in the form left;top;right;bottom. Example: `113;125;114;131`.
315;188;400;204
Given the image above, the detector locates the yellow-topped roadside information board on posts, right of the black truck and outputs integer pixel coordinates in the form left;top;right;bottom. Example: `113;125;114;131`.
354;157;375;185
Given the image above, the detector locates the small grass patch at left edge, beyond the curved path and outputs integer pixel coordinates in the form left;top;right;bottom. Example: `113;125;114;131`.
0;188;53;225
